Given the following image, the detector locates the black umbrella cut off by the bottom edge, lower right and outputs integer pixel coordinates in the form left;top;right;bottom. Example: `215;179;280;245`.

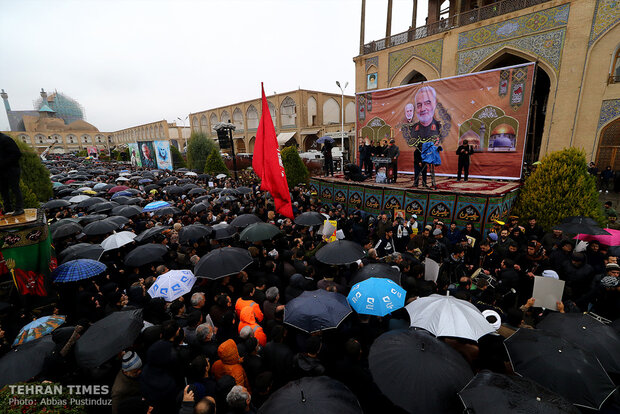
459;371;579;414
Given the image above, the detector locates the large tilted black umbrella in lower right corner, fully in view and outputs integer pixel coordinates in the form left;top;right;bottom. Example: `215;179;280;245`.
504;329;615;410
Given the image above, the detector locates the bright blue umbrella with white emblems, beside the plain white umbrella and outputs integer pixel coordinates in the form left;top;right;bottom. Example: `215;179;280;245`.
347;277;406;316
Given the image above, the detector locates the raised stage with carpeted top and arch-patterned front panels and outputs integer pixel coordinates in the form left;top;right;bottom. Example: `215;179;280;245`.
310;174;521;233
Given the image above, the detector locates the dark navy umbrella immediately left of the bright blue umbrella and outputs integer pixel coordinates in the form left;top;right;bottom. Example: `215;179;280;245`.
284;289;352;333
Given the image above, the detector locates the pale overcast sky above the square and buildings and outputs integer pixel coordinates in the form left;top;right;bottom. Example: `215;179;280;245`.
0;0;426;132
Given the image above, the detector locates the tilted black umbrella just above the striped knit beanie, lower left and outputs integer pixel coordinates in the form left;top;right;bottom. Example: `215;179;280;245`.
75;309;144;368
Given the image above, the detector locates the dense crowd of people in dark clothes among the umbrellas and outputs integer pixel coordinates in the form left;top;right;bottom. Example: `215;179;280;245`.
0;159;620;414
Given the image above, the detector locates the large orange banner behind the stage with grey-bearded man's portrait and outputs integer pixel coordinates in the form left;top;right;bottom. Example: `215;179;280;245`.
357;63;535;179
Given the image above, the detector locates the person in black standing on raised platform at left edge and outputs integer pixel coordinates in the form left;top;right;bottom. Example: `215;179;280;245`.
0;133;24;216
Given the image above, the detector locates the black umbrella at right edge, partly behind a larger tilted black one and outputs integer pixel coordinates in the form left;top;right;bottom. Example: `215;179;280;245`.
536;313;620;374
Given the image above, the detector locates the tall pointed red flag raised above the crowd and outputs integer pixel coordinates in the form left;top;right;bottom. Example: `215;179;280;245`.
252;82;293;219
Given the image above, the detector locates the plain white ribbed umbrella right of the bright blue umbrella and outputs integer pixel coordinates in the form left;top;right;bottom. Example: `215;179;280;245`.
405;294;495;341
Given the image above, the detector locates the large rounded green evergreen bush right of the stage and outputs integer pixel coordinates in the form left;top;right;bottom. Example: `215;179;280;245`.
513;148;605;231
